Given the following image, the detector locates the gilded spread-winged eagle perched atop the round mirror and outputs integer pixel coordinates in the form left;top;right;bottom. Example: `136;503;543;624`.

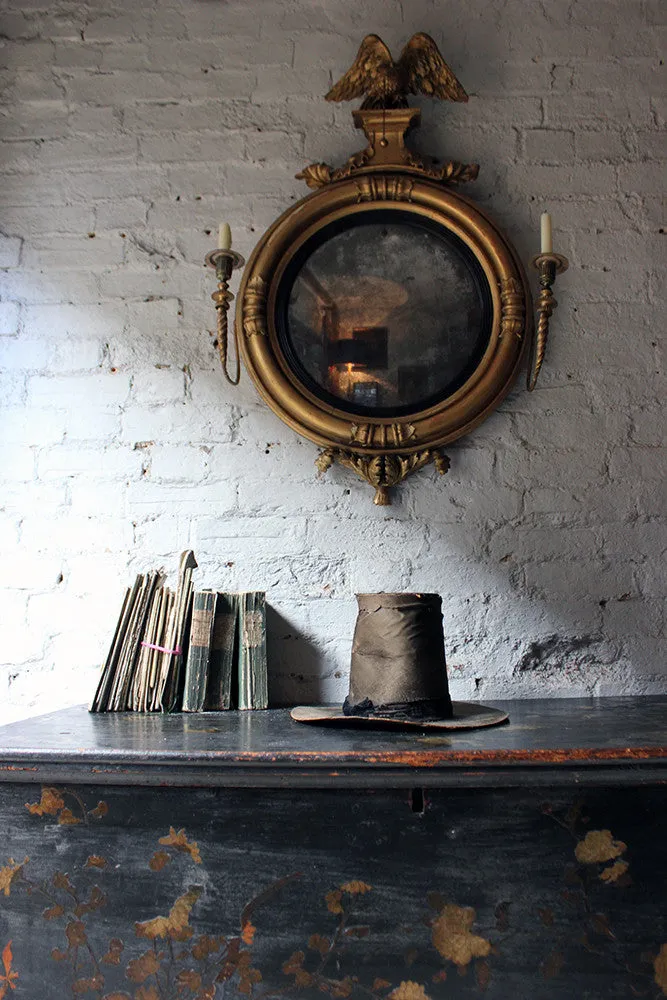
326;31;468;110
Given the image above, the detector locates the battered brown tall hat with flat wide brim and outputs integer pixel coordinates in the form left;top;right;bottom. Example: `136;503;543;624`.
291;594;508;729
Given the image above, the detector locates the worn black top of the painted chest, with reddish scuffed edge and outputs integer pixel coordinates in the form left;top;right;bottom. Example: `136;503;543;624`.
0;697;667;787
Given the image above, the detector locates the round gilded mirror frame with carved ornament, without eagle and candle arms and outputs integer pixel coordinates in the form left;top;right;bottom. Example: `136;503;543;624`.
236;108;532;504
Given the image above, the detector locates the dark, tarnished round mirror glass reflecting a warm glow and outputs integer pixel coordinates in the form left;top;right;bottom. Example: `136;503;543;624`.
276;209;492;416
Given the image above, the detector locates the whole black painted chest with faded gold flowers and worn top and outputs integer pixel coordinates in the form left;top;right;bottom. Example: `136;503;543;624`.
0;698;667;1000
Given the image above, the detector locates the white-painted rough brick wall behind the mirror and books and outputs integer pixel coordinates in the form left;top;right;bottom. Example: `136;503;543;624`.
0;0;667;721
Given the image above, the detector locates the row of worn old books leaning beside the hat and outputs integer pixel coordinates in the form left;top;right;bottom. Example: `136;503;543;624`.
90;550;268;712
